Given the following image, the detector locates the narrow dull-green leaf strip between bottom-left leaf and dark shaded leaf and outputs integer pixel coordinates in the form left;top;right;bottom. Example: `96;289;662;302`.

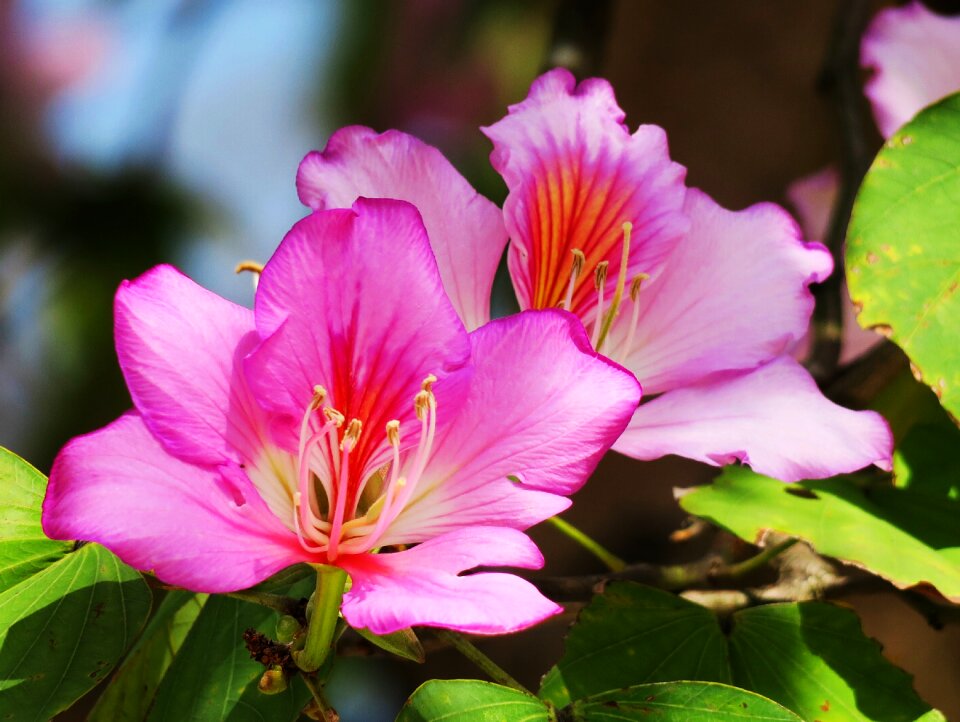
87;591;206;722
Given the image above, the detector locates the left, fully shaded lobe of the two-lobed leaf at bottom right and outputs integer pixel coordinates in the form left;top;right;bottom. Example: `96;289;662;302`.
540;583;730;707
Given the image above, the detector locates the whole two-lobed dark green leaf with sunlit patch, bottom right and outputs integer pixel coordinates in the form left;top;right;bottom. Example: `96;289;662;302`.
542;582;943;722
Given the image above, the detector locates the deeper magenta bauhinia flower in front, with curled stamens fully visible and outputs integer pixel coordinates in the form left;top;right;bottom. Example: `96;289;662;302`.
43;199;640;634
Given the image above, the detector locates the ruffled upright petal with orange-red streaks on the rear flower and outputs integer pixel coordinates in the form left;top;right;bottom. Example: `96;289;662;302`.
483;69;687;317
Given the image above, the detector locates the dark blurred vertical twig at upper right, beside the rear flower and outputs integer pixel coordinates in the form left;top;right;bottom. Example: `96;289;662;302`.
807;0;873;381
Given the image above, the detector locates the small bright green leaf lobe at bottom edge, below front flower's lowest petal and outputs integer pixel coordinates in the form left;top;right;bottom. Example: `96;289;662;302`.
397;679;550;722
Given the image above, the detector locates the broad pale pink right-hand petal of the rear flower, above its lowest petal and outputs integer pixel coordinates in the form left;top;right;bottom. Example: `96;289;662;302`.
624;189;832;395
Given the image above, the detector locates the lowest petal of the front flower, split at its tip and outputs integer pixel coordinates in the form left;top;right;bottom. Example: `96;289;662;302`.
337;527;562;634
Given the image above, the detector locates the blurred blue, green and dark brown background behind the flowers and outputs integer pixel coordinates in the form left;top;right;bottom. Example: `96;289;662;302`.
0;0;960;722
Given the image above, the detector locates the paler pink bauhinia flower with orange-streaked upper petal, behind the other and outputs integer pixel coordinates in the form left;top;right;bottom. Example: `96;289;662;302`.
297;70;891;481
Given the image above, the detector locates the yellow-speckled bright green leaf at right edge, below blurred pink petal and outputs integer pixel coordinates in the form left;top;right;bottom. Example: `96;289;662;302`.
846;94;960;417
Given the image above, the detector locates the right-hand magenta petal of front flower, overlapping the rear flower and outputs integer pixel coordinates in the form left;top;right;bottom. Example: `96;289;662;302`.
385;310;640;543
